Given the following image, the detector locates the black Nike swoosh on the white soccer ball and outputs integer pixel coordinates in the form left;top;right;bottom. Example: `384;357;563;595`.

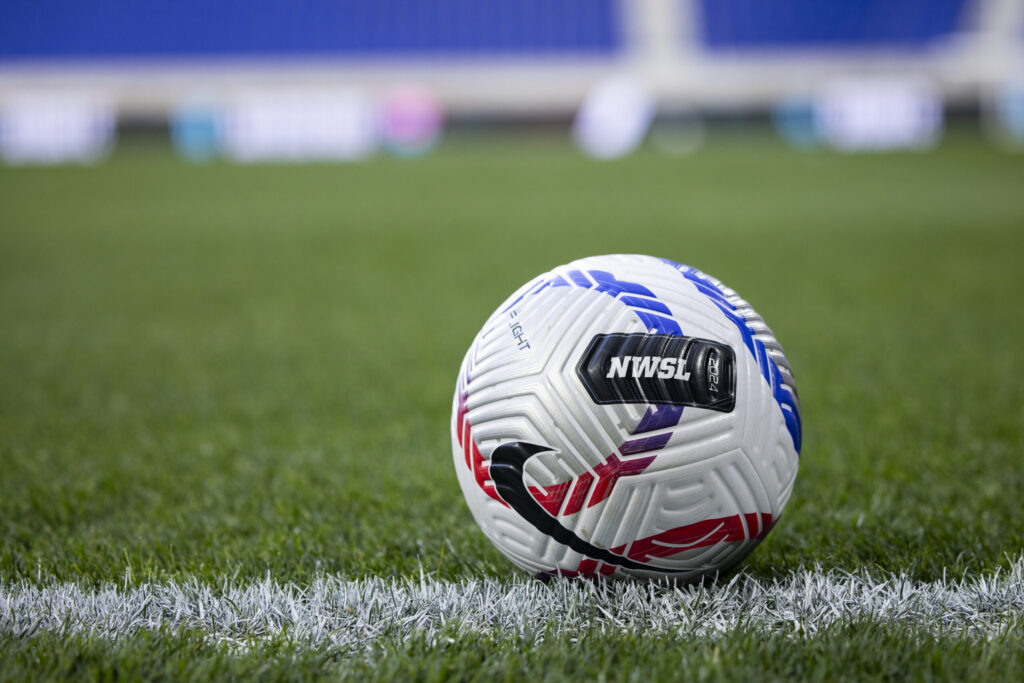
490;441;682;573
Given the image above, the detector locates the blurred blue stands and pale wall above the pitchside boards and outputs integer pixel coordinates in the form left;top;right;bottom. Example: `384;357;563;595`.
0;0;1024;116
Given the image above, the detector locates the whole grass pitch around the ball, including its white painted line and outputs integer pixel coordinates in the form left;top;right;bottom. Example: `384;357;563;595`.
0;131;1024;680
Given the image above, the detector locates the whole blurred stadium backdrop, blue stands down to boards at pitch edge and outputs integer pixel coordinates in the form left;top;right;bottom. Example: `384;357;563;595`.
0;0;1024;162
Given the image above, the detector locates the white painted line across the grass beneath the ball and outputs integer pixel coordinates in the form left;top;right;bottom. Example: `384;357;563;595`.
0;556;1024;650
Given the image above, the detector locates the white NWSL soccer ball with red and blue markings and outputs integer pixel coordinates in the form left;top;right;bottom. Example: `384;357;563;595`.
452;254;801;582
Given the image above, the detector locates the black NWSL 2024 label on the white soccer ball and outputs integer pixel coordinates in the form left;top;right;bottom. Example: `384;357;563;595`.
577;334;736;413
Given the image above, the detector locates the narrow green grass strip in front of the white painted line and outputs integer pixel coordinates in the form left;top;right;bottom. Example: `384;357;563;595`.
6;624;1024;683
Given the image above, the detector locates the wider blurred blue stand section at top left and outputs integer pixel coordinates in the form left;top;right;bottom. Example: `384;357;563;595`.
0;0;621;60
